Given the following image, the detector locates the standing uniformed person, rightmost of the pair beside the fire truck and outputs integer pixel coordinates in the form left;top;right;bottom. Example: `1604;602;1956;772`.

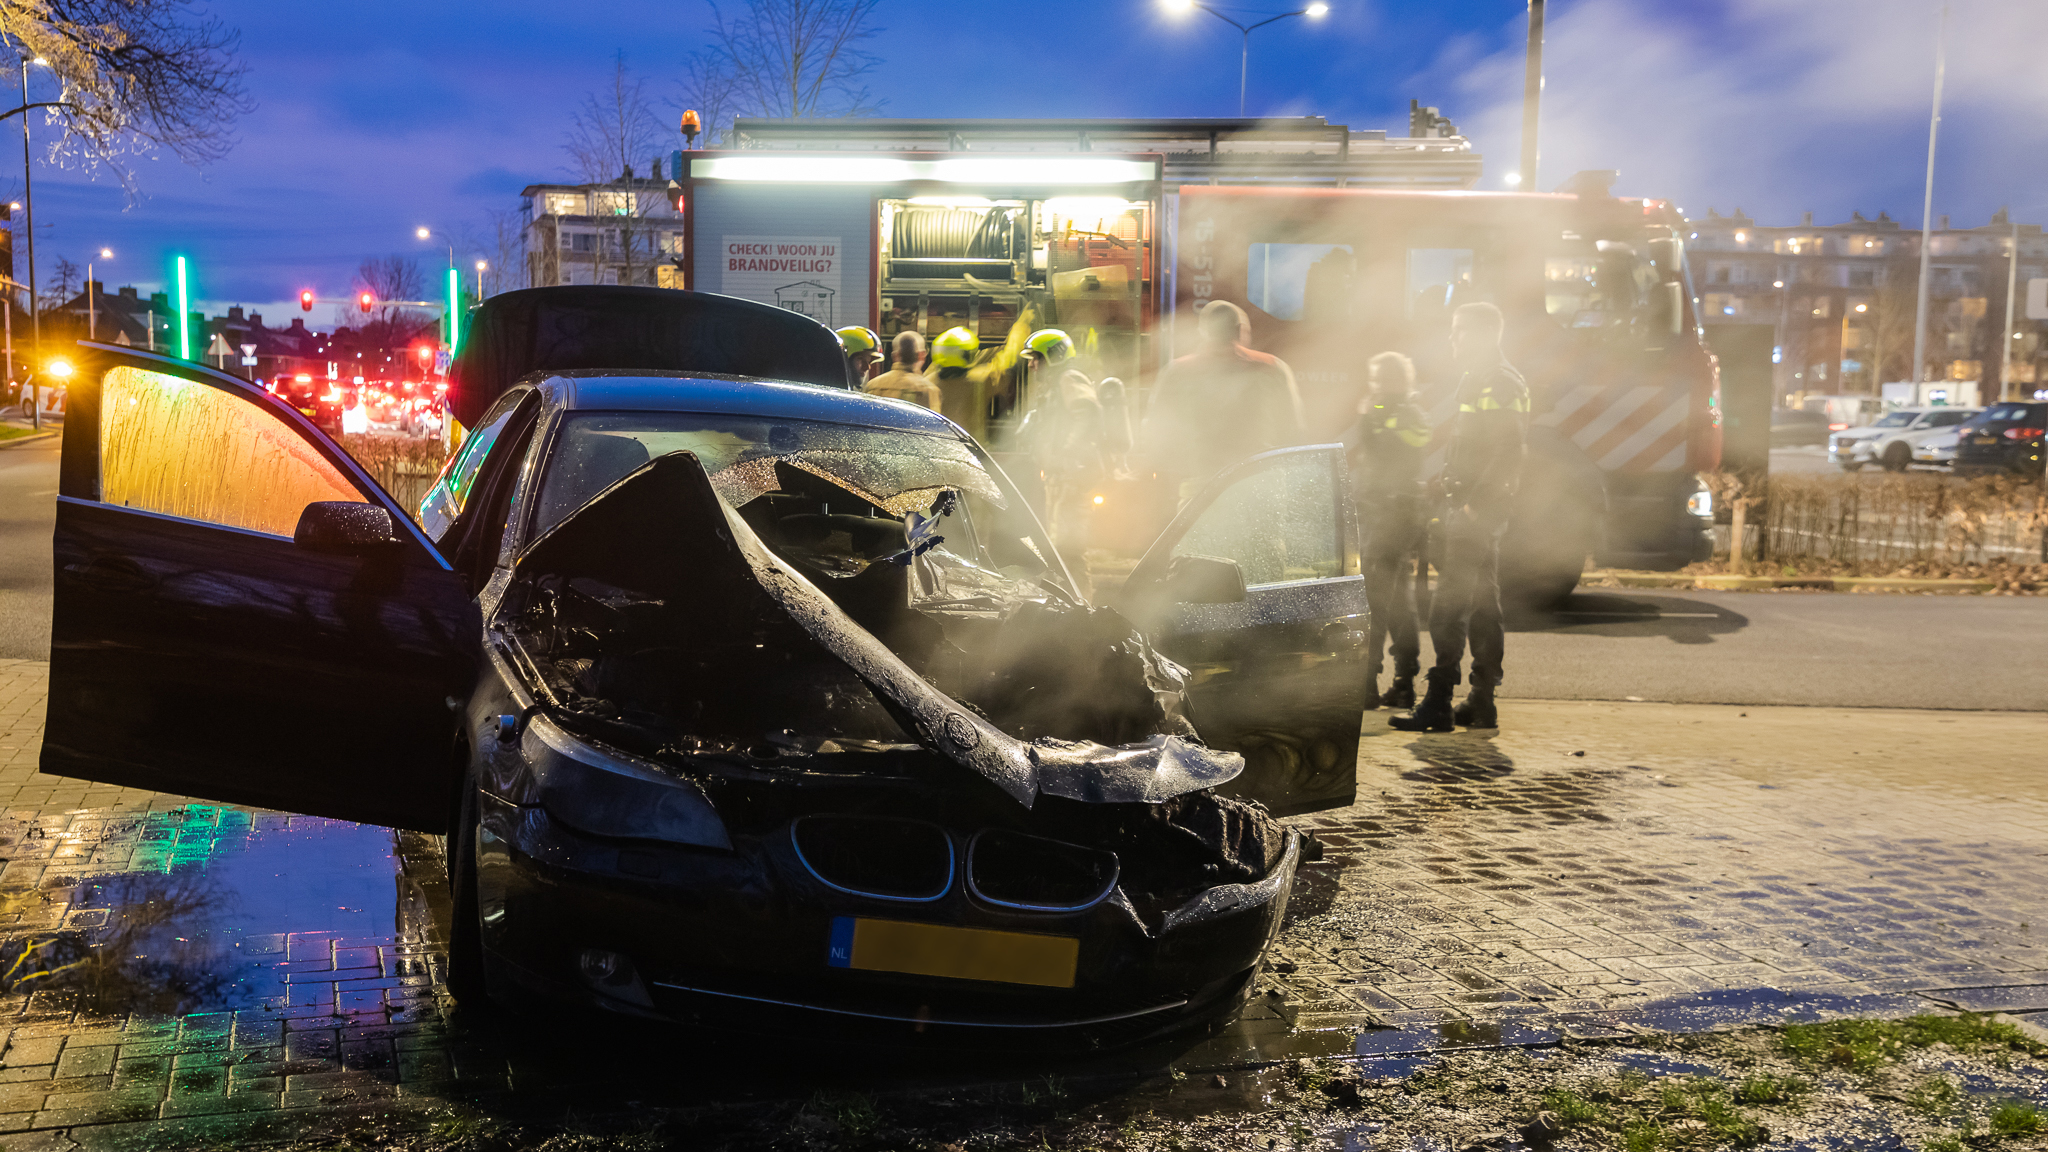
1389;303;1530;732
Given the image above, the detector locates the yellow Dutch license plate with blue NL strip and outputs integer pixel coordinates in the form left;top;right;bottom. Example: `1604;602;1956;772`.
825;916;1081;988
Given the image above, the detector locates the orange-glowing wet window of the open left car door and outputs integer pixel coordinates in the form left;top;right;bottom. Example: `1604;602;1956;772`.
100;365;369;537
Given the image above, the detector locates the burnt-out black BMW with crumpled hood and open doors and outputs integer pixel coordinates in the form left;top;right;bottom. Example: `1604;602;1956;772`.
41;287;1364;1050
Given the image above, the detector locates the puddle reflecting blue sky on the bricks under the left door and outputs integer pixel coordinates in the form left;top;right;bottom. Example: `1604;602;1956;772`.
0;806;397;1015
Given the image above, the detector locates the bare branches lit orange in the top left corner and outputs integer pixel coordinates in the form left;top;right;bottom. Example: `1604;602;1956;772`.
0;0;256;193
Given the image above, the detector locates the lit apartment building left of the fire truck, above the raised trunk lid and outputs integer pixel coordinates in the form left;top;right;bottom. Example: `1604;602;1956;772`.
520;160;686;287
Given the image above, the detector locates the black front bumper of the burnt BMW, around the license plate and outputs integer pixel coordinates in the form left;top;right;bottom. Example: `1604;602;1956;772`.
477;795;1300;1047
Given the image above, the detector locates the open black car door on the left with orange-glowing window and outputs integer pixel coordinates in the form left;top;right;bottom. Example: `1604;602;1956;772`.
43;344;481;830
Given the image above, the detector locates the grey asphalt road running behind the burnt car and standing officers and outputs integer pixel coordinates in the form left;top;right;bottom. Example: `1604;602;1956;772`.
0;441;2048;711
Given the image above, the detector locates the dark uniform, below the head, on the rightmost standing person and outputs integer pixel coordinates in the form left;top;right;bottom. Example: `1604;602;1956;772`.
1430;361;1530;688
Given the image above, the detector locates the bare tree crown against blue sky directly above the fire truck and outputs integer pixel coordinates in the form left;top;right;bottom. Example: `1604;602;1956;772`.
684;0;883;137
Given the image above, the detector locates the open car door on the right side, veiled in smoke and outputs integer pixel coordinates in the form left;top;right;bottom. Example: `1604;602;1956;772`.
1118;445;1366;816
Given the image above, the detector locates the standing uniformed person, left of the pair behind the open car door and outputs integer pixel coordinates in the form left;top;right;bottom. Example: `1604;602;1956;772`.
1346;353;1430;709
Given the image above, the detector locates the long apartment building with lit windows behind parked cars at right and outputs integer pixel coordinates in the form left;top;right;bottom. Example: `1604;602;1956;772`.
1686;209;2048;402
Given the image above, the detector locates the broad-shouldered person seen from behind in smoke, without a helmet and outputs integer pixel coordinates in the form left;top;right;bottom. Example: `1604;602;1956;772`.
1143;299;1305;502
